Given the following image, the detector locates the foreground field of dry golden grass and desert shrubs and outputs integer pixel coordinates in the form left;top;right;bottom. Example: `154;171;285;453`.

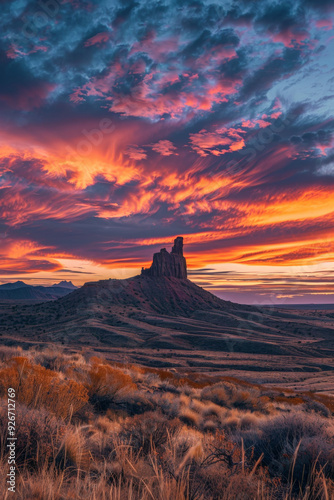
0;350;334;500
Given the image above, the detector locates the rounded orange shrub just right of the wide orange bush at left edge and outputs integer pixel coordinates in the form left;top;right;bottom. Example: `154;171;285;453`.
88;360;137;411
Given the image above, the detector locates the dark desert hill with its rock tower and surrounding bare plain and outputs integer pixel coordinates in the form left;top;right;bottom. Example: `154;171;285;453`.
0;238;334;389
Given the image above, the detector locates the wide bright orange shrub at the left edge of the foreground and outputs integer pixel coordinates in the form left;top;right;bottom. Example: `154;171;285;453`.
0;357;88;419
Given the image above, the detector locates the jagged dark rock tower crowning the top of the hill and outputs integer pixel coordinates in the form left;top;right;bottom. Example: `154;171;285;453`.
141;236;187;279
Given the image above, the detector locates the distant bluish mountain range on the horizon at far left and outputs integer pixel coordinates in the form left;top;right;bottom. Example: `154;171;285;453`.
0;281;77;301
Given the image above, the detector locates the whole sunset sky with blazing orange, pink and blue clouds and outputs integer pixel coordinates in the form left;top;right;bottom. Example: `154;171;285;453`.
0;0;334;304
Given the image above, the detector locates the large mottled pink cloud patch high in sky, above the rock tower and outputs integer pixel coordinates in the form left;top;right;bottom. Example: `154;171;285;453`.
70;40;242;120
